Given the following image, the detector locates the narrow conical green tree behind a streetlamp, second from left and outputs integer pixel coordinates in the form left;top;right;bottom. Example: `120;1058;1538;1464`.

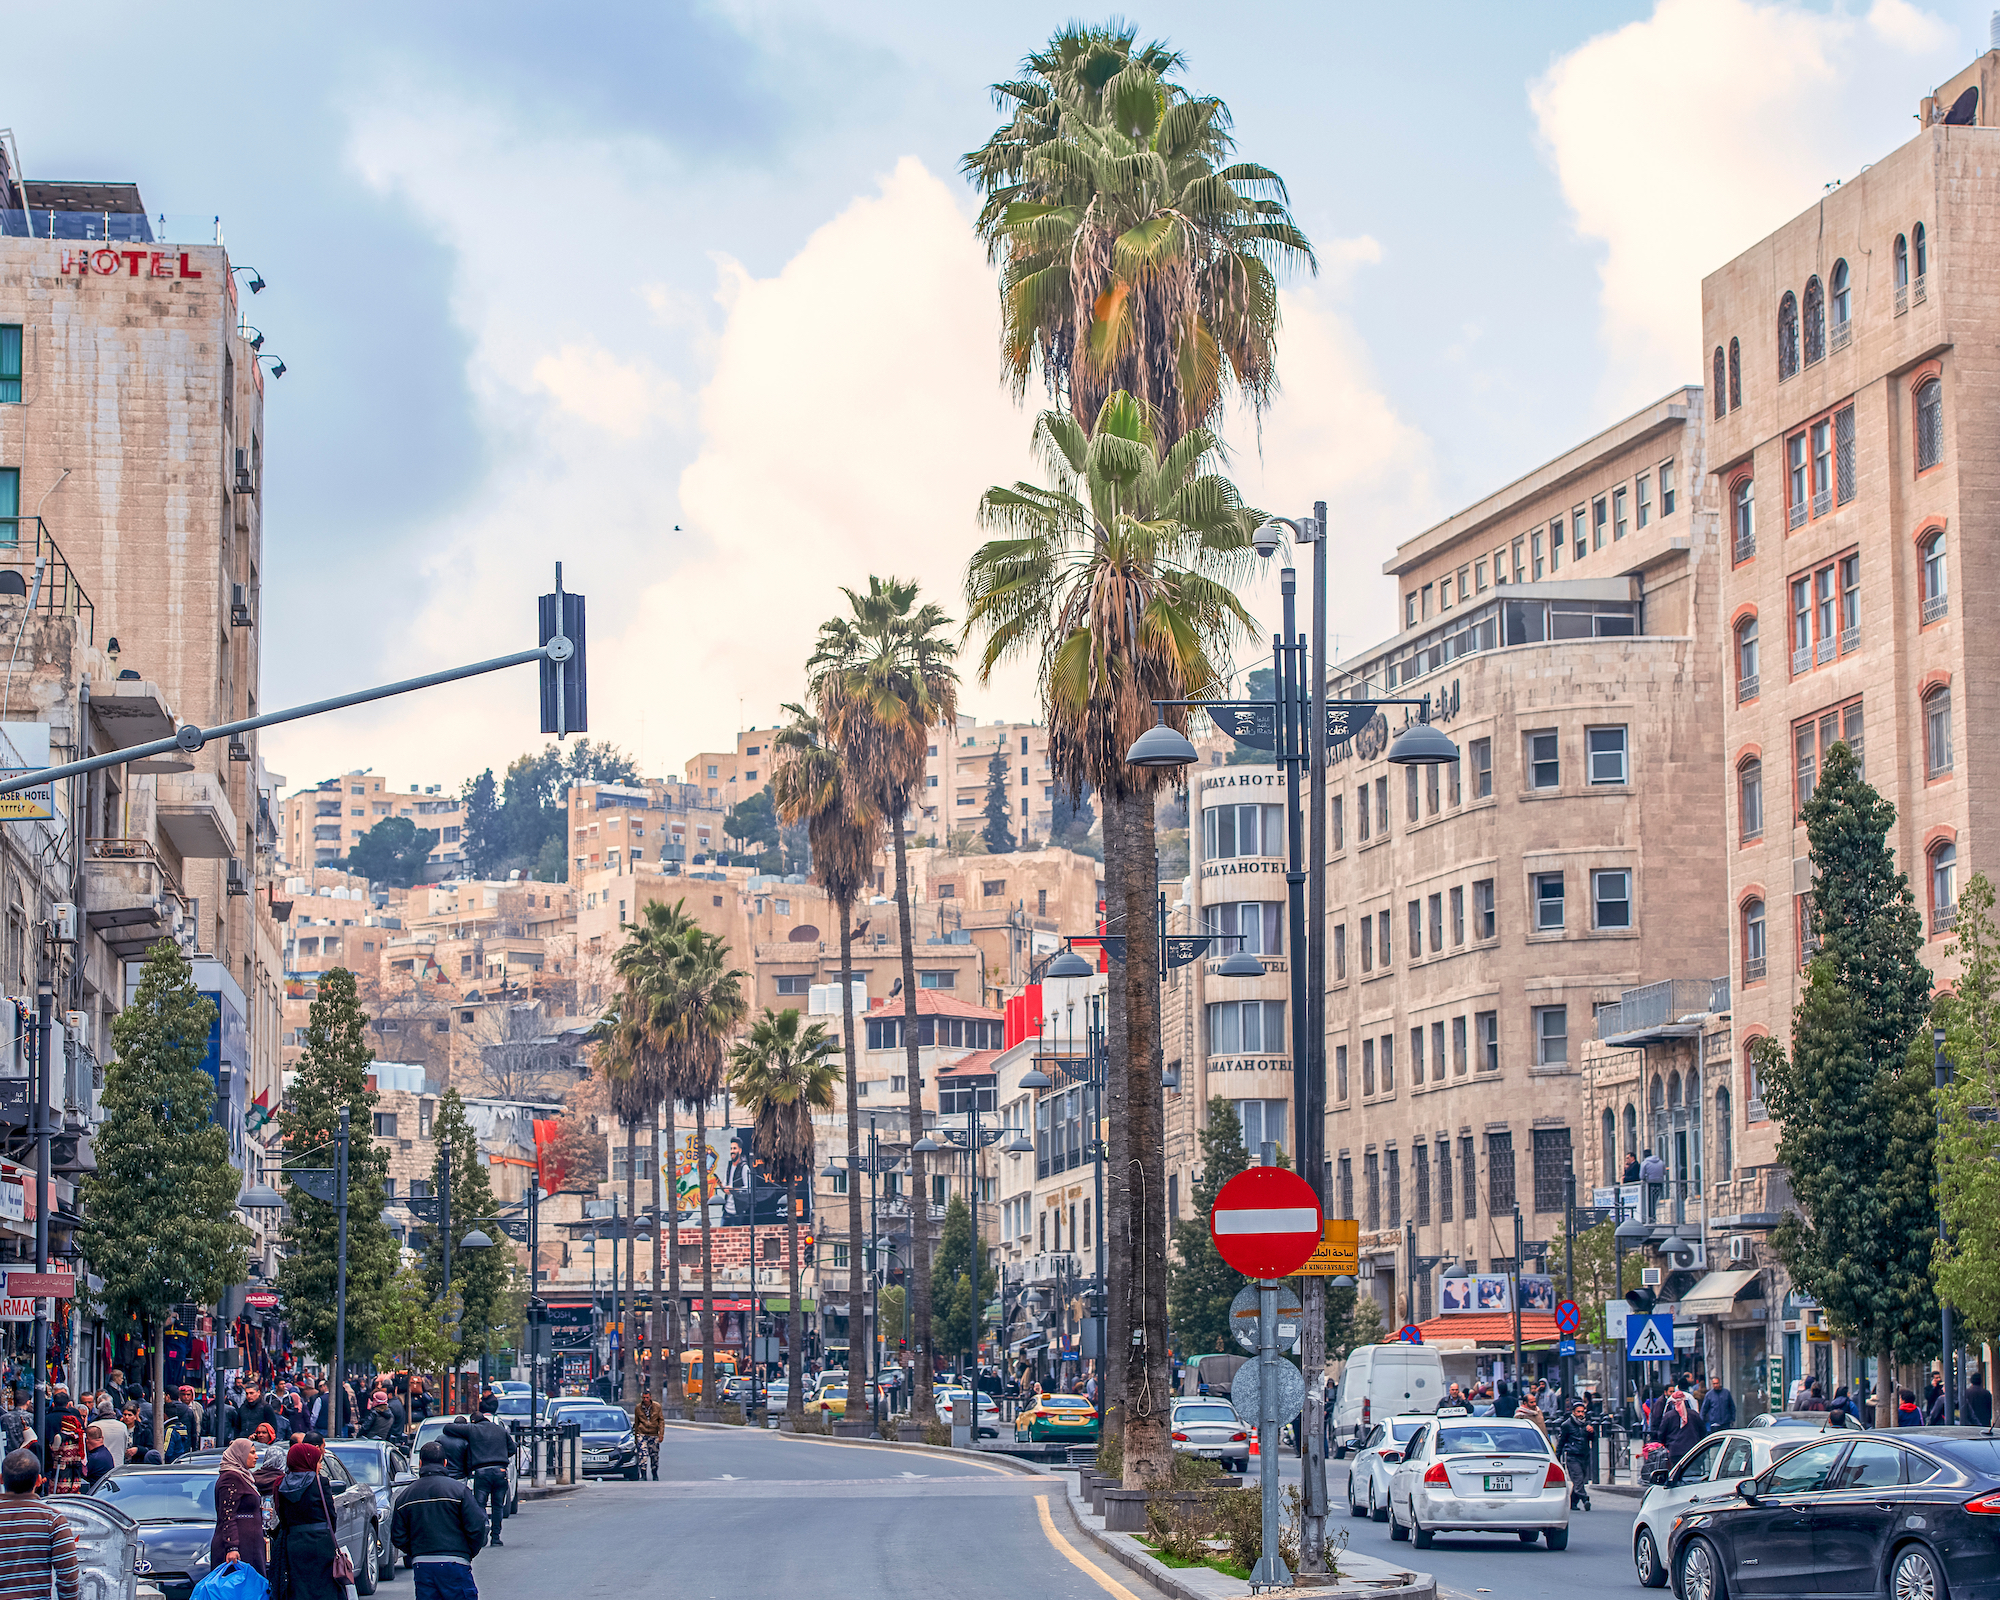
278;966;396;1362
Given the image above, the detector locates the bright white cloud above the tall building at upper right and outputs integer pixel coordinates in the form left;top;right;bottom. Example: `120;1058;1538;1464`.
1530;0;1958;406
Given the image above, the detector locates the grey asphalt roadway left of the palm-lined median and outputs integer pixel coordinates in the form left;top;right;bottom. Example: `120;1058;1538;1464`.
468;1428;1158;1600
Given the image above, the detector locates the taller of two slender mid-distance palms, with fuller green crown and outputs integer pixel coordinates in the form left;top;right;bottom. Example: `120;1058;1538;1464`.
806;576;958;1416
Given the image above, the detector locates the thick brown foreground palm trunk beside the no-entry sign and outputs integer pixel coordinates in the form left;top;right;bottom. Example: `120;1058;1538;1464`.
1114;794;1174;1488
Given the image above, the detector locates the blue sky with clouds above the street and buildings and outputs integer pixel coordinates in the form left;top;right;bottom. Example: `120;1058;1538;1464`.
0;0;1988;788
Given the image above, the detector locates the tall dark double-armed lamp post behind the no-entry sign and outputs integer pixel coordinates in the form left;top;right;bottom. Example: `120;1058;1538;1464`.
1126;500;1458;1572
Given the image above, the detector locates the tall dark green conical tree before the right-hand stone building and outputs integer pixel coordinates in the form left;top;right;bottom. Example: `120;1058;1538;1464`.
1756;744;1938;1426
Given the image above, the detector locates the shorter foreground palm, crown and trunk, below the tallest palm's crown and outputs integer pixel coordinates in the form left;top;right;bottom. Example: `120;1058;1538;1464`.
966;394;1262;1484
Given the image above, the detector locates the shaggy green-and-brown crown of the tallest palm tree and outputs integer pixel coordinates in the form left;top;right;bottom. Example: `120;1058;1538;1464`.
960;26;1316;444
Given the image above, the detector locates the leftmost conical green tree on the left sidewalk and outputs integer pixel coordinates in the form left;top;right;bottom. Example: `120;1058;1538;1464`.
80;940;252;1448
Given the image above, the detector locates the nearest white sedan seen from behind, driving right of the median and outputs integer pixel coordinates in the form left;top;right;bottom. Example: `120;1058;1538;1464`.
1388;1416;1570;1550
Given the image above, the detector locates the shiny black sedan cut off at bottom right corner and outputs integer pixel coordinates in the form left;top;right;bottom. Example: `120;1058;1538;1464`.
1668;1428;2000;1600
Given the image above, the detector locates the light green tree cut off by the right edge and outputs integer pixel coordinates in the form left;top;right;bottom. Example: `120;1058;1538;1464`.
1936;872;2000;1344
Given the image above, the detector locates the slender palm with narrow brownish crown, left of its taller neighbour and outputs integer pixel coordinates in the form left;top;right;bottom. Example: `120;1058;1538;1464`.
770;706;882;1416
